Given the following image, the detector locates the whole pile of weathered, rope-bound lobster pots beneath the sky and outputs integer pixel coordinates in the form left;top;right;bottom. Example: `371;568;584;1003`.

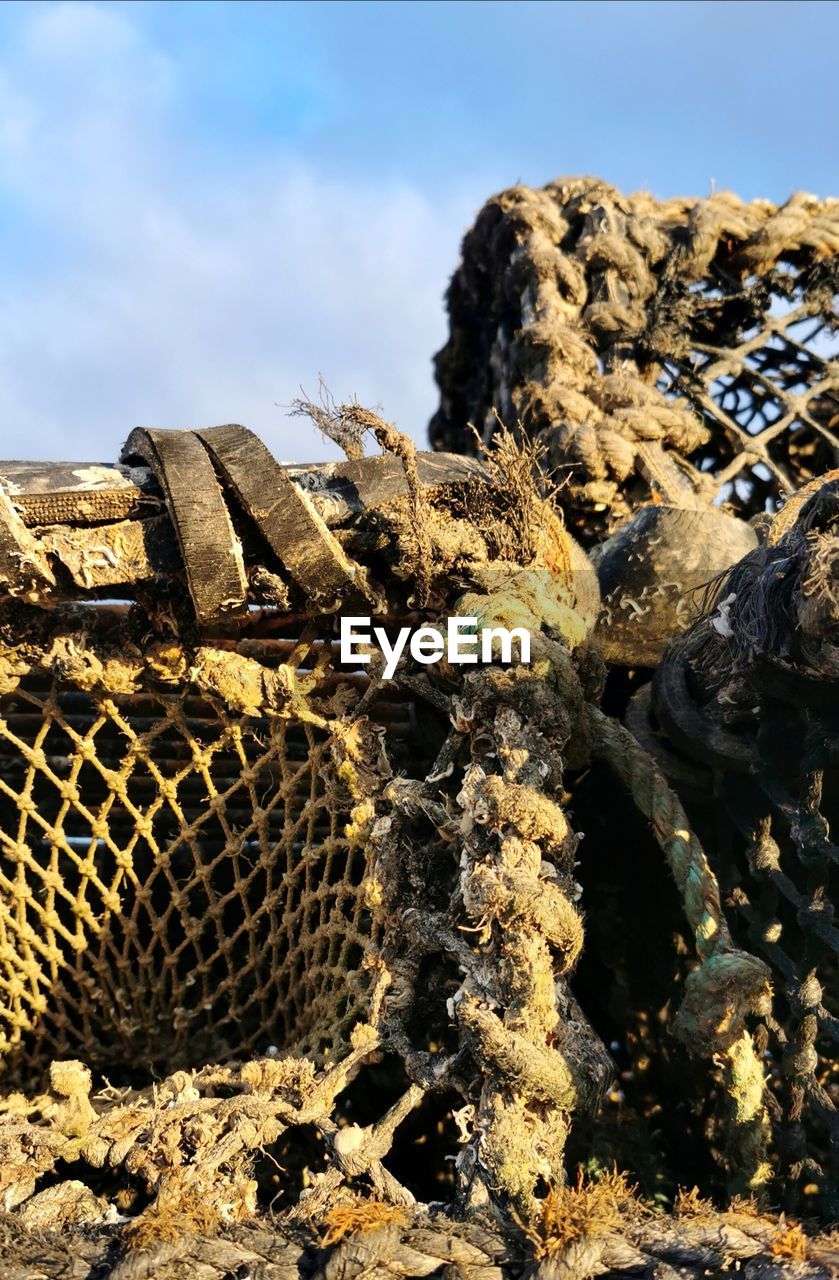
0;179;839;1280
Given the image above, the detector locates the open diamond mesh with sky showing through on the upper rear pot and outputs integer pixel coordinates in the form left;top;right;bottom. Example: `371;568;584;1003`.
657;275;839;516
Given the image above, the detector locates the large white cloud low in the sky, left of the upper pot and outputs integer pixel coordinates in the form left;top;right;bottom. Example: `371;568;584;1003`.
0;4;471;460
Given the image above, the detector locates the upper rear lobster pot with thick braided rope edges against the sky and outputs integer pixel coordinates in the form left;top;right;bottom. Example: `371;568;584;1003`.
430;178;839;545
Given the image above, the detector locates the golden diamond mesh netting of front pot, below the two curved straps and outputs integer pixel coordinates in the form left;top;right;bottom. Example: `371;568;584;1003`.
0;624;434;1076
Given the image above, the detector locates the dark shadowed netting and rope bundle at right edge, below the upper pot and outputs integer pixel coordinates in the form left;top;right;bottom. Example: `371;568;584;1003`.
630;474;839;1217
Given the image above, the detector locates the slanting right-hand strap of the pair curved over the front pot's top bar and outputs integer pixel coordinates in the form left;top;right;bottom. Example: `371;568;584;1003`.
195;425;364;600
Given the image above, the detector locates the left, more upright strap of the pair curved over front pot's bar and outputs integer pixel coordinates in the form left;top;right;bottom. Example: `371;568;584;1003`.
123;428;247;626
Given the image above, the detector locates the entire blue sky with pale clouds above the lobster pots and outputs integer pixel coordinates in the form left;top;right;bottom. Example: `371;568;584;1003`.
0;0;839;460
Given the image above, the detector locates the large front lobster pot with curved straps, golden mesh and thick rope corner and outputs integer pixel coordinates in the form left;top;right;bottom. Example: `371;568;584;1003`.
0;406;831;1276
